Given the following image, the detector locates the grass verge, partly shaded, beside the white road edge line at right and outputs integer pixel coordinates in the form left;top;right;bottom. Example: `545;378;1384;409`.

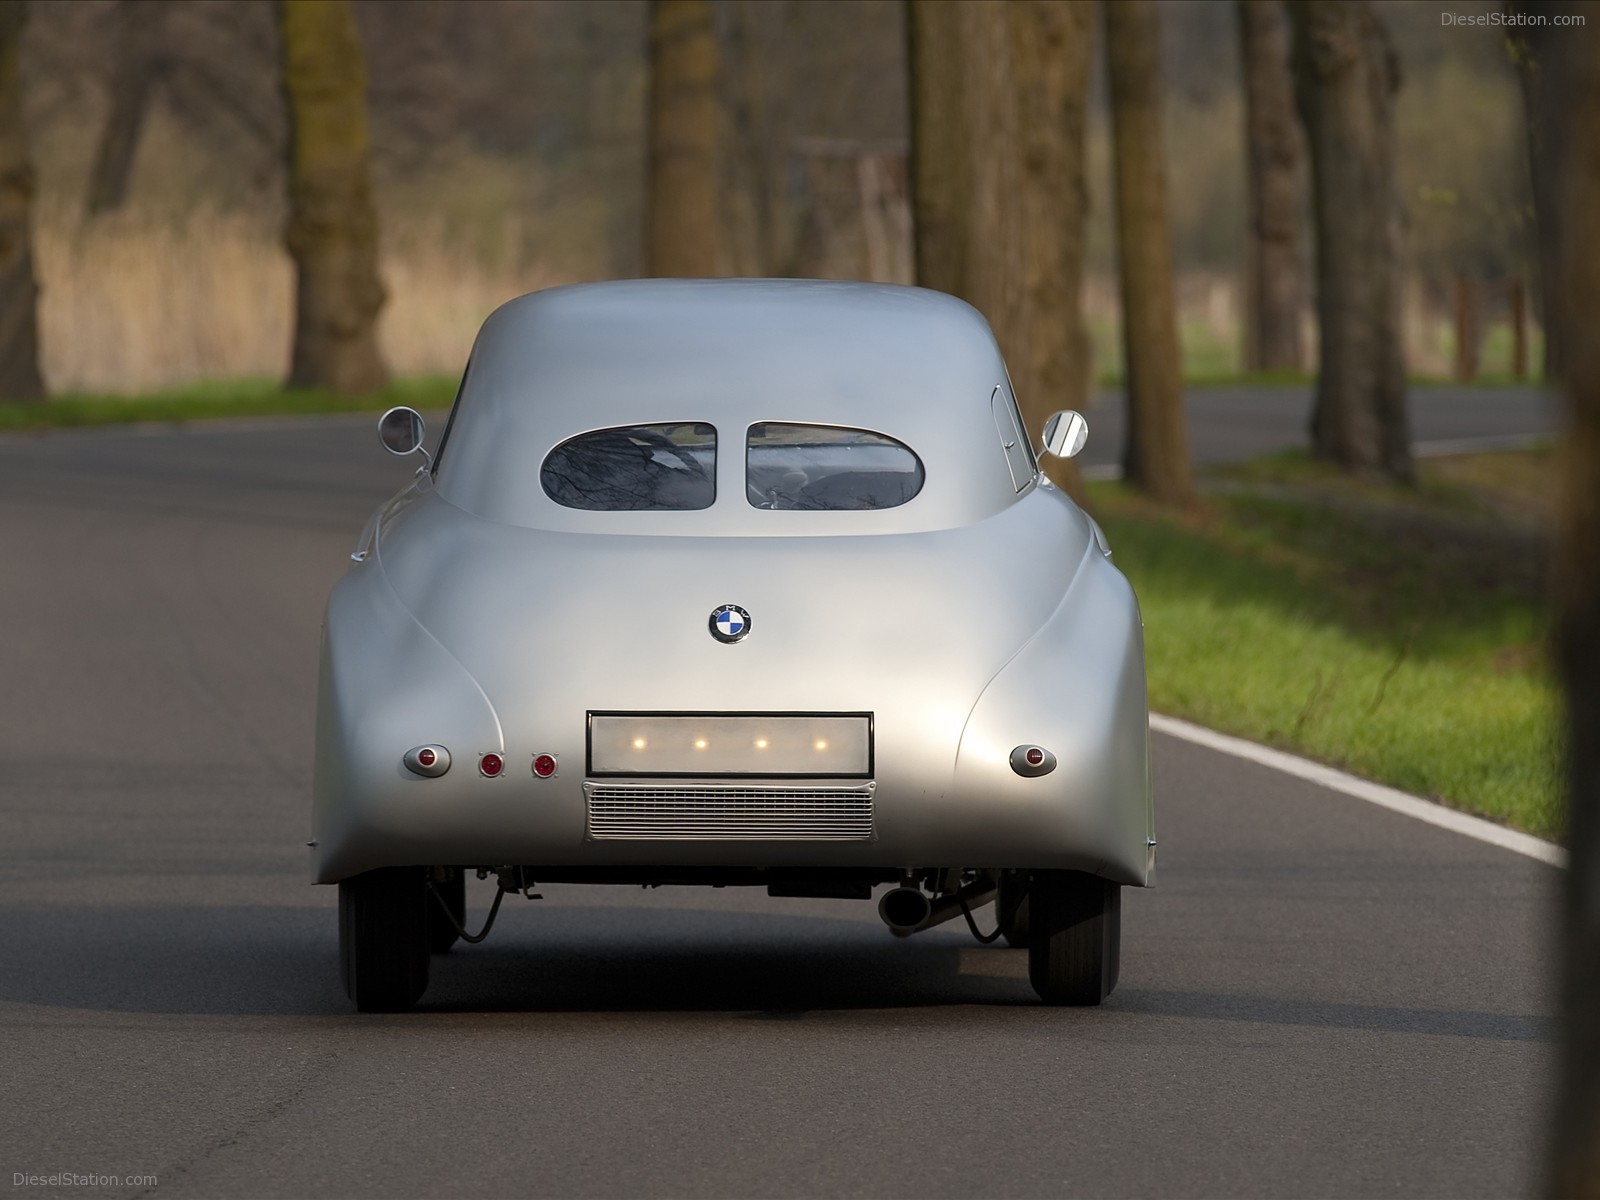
1091;453;1560;837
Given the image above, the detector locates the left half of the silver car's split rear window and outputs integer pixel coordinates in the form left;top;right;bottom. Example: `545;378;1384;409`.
539;421;717;512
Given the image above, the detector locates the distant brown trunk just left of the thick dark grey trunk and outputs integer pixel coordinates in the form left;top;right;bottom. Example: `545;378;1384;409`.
1238;0;1307;371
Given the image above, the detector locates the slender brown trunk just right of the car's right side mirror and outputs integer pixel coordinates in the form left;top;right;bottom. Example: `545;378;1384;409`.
1104;0;1194;504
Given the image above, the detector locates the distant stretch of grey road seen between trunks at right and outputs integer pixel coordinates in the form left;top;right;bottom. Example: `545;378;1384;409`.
1083;386;1560;474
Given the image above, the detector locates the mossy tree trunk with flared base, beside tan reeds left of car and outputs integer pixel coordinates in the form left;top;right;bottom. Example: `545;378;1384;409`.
278;0;389;394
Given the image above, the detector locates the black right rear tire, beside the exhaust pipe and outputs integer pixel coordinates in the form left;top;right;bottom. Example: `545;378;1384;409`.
1027;870;1122;1005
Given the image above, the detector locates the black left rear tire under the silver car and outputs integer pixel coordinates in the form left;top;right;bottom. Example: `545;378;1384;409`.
339;867;429;1013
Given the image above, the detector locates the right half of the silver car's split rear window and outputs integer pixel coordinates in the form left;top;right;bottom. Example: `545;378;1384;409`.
744;421;923;510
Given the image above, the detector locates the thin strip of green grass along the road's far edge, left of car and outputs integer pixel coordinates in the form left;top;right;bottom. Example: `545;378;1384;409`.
0;374;458;432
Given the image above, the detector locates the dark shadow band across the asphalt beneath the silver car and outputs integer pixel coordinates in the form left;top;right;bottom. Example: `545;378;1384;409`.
0;904;1555;1042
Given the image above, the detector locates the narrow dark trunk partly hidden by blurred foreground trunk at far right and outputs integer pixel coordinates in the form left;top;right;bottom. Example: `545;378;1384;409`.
1506;8;1566;382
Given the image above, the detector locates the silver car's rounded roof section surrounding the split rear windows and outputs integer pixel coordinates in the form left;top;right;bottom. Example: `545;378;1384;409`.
437;280;1016;533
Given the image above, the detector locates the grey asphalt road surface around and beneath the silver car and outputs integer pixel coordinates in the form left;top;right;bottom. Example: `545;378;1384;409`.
0;390;1557;1197
